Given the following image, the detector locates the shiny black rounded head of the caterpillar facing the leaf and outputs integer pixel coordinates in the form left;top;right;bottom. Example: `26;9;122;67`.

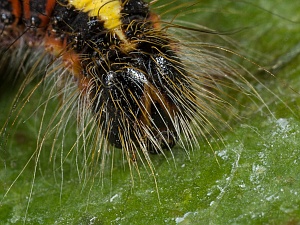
92;44;189;153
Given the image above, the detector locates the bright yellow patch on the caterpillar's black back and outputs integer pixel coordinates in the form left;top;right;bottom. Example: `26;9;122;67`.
69;0;122;30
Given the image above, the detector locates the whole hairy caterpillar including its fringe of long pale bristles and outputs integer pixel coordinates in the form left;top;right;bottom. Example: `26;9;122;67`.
0;0;298;221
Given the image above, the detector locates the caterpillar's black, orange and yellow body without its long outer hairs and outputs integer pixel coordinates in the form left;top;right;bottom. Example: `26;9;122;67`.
0;0;197;153
